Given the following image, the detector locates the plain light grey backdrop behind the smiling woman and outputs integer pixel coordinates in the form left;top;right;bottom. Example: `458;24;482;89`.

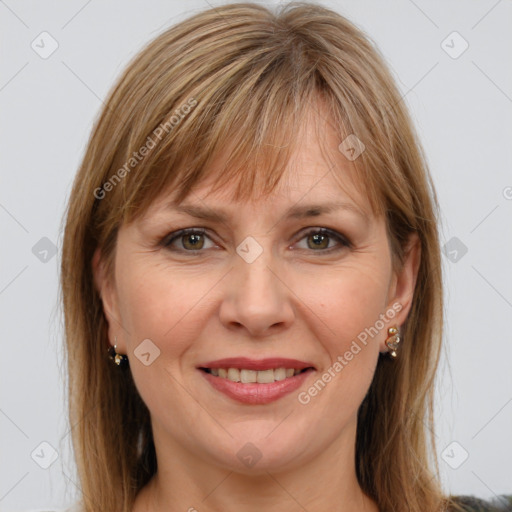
0;0;512;511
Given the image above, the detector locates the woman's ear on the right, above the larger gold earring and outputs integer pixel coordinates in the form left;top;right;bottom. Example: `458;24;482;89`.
381;233;421;352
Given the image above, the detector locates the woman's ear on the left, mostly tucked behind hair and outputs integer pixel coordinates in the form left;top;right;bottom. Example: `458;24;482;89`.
92;247;124;352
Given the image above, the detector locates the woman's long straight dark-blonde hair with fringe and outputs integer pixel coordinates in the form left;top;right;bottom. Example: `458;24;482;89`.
61;2;460;512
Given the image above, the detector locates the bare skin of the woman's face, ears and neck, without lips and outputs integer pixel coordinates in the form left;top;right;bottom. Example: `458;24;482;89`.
93;106;419;512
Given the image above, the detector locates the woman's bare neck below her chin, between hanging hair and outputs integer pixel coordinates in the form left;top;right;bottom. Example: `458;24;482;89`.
133;423;378;512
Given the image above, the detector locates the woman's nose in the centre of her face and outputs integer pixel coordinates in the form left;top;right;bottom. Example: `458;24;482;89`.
219;250;295;337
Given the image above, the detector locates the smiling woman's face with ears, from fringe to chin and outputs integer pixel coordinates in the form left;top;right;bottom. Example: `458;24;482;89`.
94;117;419;473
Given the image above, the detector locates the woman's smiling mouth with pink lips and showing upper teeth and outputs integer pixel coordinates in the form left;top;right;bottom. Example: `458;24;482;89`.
197;358;316;405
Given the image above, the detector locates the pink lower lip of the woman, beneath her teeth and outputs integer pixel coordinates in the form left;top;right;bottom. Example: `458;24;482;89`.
198;368;314;405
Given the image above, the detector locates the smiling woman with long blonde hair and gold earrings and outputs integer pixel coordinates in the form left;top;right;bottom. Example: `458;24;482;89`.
62;4;505;512
